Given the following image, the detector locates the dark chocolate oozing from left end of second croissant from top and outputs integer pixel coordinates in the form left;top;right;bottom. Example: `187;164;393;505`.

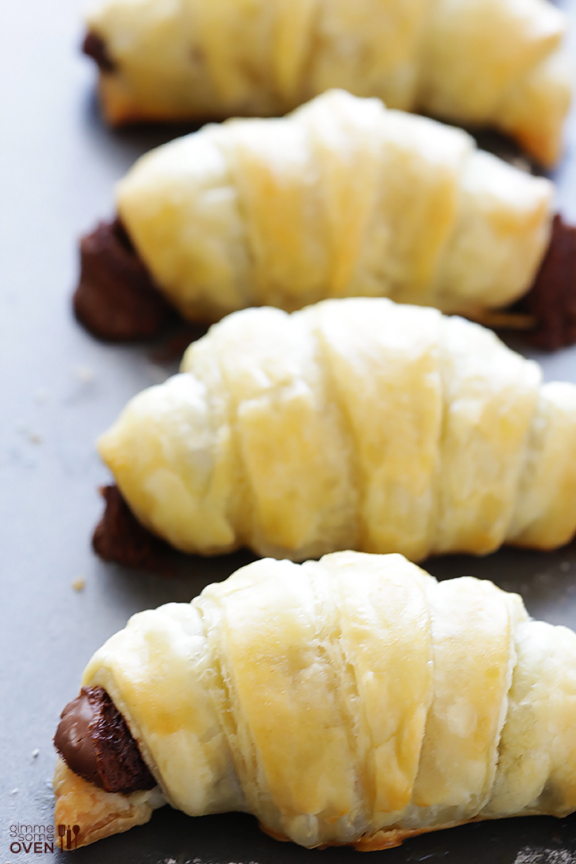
73;219;175;341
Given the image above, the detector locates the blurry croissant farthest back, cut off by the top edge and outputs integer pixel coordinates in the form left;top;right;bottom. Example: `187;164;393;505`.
84;0;571;164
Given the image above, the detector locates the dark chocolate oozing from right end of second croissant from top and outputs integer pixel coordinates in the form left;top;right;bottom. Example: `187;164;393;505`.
509;214;576;351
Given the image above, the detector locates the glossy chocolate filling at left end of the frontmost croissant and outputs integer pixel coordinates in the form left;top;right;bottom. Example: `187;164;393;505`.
54;687;156;795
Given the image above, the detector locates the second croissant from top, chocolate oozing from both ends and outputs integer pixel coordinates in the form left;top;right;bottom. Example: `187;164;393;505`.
75;91;576;336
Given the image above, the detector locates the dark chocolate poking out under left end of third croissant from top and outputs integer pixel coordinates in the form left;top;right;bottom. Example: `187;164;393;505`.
92;486;177;573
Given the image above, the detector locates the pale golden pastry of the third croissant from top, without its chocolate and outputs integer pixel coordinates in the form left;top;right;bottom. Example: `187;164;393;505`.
98;298;576;561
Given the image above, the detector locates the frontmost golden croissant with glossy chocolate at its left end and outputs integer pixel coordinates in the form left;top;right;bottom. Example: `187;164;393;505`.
55;552;576;850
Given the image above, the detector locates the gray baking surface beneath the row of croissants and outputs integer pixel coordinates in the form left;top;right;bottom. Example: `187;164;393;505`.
0;0;576;864
